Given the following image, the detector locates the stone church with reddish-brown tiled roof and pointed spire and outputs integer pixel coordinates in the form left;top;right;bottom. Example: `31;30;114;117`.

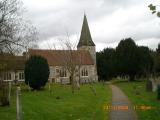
28;15;98;84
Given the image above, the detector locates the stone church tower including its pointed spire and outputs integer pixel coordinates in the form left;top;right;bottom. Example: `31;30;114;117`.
77;14;98;81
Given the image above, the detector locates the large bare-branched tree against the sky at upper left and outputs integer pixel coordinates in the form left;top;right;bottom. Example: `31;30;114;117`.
0;0;37;54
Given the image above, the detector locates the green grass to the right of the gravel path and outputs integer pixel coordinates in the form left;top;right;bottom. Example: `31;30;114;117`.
115;82;160;120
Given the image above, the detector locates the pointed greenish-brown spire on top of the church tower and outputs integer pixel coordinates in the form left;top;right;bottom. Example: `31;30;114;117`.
77;14;95;47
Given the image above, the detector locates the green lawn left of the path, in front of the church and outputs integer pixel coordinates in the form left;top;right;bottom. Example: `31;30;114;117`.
0;83;111;120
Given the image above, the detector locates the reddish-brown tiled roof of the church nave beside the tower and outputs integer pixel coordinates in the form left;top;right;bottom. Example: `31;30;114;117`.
28;49;94;66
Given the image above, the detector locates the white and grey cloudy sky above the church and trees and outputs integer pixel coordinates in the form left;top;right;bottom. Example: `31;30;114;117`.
23;0;160;51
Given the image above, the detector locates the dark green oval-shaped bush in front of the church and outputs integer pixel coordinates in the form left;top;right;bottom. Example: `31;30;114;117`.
24;56;49;90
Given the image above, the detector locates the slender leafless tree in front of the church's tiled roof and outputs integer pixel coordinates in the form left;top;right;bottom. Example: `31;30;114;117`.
59;34;82;93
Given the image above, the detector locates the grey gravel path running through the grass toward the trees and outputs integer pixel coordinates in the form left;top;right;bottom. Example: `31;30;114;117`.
109;85;138;120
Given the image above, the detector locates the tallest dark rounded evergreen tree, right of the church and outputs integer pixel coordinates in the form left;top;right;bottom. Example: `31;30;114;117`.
116;38;139;81
